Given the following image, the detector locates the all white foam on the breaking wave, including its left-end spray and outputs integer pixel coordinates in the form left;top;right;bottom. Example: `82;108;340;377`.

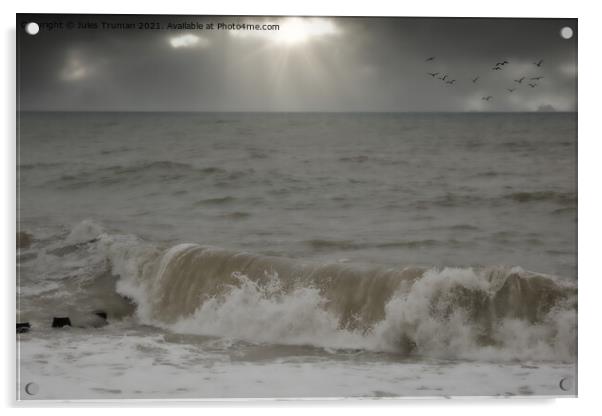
52;223;576;361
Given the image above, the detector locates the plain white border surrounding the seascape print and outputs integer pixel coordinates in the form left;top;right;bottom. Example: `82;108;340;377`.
0;0;602;416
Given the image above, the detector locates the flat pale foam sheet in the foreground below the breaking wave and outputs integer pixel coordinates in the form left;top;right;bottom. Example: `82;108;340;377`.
18;325;576;400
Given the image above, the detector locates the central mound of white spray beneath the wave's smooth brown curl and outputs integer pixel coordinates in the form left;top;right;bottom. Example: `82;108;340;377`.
168;275;367;348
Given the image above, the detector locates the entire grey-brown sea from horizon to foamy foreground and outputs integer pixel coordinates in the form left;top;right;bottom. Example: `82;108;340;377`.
16;112;577;400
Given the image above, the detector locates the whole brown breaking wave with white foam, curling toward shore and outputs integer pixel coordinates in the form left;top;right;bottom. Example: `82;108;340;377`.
19;221;577;361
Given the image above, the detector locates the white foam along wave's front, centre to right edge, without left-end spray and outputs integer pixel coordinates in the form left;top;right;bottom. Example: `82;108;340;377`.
149;269;576;362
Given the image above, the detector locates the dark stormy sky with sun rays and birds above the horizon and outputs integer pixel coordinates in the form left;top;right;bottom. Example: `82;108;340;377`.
17;15;577;112
